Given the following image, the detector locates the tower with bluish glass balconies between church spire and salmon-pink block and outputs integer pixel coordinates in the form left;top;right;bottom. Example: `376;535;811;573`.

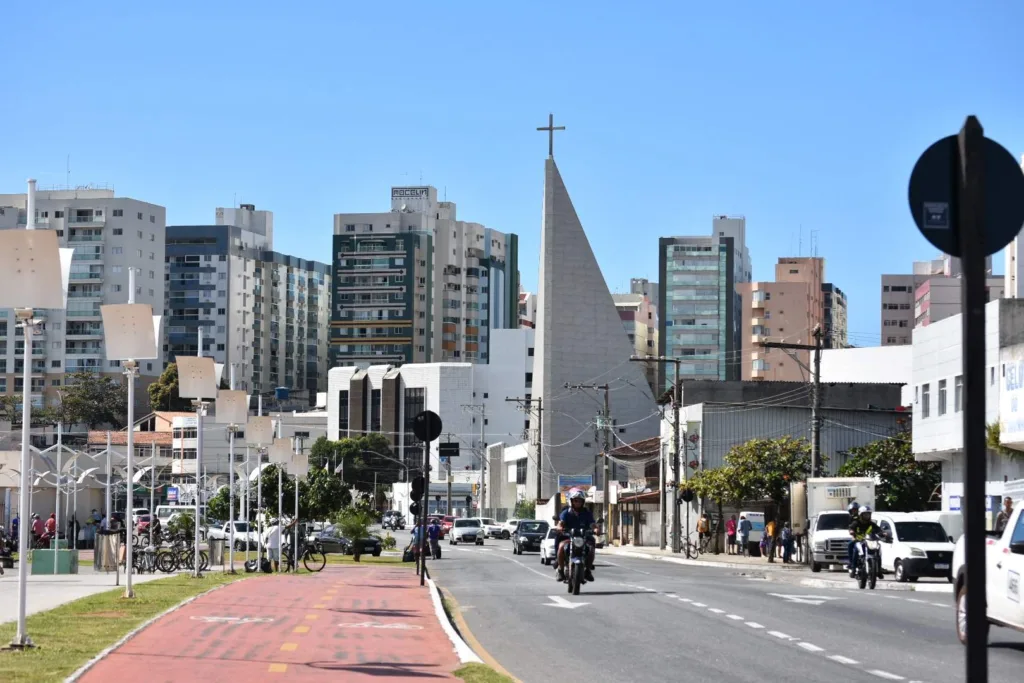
657;216;752;387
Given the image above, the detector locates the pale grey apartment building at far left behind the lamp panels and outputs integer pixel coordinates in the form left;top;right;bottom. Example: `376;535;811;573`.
0;185;166;407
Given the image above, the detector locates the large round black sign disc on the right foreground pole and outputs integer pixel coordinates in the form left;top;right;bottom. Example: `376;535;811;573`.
909;135;1024;256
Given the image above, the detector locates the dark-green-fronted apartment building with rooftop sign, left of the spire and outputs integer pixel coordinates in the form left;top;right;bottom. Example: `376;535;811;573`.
330;186;519;366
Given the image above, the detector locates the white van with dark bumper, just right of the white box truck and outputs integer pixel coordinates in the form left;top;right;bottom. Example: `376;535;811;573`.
876;513;954;583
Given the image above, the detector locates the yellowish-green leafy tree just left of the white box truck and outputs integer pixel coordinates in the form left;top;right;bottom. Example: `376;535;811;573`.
725;436;811;510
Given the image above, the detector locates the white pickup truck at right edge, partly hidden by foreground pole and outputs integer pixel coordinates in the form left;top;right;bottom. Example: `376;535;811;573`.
953;482;1024;644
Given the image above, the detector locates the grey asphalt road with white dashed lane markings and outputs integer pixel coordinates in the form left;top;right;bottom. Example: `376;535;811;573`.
428;541;1024;683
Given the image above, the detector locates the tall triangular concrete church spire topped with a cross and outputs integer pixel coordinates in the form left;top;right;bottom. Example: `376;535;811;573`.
526;131;659;499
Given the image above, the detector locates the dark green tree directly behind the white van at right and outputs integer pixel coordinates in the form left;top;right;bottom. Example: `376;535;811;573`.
839;430;942;512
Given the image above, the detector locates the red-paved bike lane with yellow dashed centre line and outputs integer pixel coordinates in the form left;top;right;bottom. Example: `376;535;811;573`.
79;566;460;683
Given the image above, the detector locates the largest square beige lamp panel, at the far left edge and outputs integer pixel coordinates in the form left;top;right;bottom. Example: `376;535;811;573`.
0;230;71;309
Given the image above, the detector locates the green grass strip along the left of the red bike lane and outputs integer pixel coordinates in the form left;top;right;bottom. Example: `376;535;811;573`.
0;571;246;683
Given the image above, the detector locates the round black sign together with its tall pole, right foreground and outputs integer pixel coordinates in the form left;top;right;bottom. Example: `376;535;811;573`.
908;116;1024;683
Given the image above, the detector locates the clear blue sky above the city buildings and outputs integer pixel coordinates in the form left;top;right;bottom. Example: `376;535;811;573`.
0;0;1024;344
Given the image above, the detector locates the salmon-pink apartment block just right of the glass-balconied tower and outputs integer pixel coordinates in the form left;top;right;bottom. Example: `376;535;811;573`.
736;256;825;382
